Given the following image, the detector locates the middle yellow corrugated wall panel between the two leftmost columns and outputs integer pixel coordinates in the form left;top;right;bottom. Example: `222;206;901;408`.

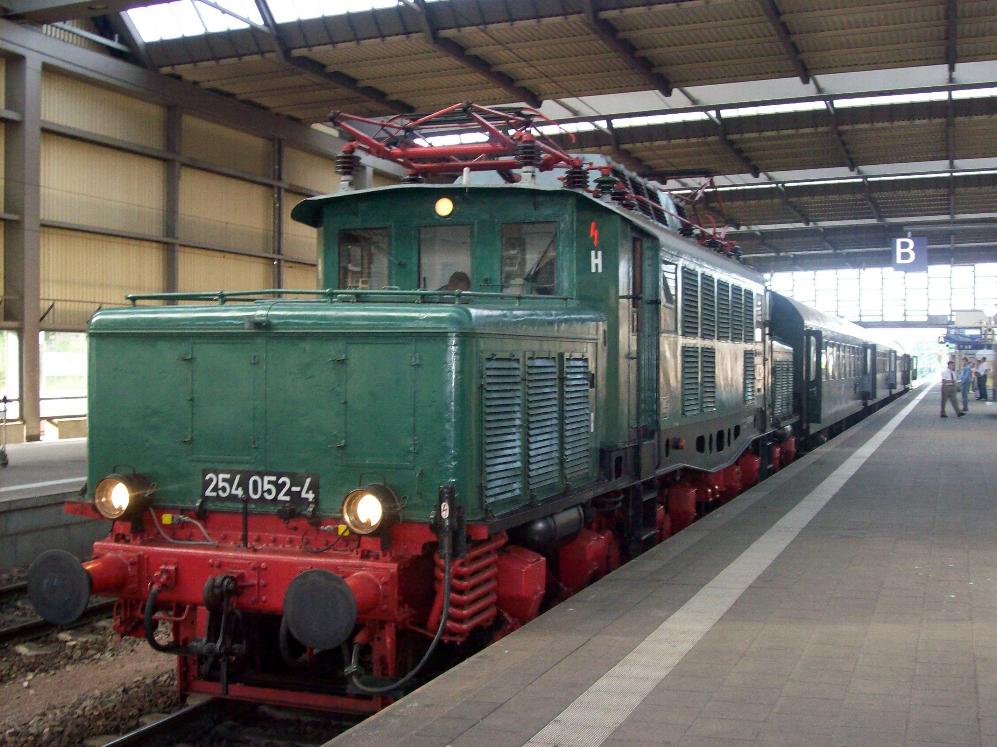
41;133;165;236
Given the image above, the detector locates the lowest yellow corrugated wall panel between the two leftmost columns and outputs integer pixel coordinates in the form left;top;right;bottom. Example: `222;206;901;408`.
41;228;165;329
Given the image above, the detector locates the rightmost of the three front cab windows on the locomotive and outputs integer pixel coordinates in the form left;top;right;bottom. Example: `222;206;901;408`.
502;223;557;296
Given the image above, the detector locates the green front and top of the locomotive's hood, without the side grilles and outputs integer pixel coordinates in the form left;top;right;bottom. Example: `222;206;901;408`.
89;301;602;520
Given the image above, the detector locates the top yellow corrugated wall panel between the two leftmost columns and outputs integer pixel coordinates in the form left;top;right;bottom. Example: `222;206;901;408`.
42;70;166;148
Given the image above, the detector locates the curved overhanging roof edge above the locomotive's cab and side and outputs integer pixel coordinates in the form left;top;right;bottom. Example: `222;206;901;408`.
291;184;765;285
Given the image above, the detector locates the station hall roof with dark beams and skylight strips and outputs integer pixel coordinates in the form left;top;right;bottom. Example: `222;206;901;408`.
8;0;997;270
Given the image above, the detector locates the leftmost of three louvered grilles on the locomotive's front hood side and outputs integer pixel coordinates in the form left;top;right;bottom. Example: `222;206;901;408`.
482;358;523;503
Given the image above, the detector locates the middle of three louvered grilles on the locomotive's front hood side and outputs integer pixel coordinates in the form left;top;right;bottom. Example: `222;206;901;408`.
526;358;561;490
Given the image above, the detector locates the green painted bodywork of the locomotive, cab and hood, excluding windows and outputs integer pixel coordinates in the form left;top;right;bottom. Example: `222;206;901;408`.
89;185;766;521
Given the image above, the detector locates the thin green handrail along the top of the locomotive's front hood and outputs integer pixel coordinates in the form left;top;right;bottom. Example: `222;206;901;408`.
126;288;574;306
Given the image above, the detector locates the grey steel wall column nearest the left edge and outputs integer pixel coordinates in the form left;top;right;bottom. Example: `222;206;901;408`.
4;54;42;441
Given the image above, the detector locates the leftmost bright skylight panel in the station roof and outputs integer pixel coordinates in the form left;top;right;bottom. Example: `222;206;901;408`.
127;0;263;42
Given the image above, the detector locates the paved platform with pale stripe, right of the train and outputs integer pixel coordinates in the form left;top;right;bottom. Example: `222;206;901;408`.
329;385;997;747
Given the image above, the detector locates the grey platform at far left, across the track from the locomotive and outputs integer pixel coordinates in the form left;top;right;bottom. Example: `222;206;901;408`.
0;438;97;568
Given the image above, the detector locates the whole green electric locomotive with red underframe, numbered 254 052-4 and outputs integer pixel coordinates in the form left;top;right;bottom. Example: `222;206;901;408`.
29;108;793;712
